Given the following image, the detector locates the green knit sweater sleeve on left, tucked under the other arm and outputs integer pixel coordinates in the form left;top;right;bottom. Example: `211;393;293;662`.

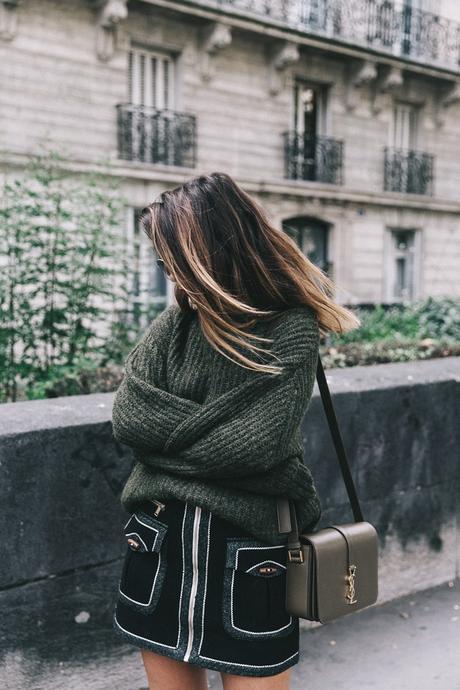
112;306;200;451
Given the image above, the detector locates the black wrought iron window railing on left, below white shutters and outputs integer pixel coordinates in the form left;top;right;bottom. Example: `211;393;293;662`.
117;103;196;168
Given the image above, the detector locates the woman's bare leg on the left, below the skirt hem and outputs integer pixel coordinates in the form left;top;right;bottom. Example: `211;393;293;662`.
141;649;209;690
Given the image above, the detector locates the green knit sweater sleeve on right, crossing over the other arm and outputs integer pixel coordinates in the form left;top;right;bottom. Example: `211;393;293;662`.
138;306;319;479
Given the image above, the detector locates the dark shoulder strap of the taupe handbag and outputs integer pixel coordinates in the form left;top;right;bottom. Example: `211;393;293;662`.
277;354;364;536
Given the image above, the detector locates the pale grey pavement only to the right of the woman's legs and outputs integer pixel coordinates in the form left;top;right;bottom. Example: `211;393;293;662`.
292;580;460;690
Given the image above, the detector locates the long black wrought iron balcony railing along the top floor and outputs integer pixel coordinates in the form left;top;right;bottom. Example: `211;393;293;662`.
202;0;460;71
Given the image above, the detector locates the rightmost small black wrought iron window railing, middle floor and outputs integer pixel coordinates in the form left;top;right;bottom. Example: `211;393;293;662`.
384;148;434;195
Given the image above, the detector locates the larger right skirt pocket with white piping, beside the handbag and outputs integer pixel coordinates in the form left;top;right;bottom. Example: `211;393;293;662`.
222;538;295;640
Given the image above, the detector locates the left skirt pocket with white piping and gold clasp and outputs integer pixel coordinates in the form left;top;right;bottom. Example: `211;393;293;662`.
119;510;168;613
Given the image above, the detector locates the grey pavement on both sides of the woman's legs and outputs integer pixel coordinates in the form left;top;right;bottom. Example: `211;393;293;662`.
0;580;460;690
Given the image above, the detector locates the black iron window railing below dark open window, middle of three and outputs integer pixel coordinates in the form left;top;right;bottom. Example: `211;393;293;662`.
283;132;343;184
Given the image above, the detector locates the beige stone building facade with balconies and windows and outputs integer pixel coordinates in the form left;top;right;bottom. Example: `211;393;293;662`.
0;0;460;318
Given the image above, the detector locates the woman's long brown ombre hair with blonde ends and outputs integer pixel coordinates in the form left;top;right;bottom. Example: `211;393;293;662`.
140;172;360;373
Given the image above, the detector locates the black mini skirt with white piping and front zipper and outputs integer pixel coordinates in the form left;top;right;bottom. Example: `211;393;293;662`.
113;499;299;676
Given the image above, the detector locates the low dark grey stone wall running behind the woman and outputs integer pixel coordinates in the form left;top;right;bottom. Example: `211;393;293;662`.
0;357;460;601
